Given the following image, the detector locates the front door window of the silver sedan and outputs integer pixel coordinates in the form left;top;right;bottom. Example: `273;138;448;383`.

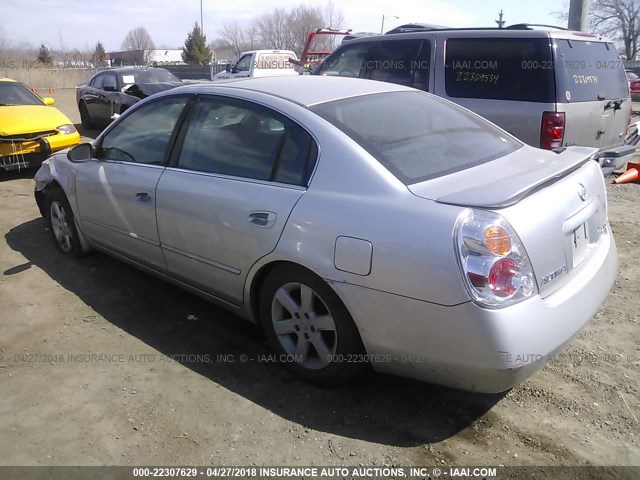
98;97;189;165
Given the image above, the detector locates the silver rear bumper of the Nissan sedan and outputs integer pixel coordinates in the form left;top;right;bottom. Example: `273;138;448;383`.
332;230;617;393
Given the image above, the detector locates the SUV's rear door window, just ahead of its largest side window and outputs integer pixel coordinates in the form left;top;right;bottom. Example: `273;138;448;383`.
365;39;431;90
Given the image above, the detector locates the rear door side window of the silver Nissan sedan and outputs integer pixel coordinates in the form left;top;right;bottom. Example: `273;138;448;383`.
178;97;315;185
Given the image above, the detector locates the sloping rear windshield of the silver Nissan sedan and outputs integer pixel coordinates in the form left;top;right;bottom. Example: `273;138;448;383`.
311;91;522;185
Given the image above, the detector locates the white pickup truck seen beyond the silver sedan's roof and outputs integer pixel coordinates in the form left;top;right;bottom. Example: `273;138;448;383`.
213;50;298;80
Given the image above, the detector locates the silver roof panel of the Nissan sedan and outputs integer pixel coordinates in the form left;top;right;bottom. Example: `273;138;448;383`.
170;75;415;107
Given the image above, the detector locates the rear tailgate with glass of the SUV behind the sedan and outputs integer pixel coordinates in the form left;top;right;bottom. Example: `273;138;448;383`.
554;39;631;150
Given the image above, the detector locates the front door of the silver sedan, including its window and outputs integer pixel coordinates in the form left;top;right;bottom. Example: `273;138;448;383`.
76;96;189;269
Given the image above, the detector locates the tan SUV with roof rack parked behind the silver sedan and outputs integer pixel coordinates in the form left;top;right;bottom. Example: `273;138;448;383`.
314;25;635;173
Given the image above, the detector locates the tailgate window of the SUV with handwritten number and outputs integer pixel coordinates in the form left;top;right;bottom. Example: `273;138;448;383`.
555;39;629;102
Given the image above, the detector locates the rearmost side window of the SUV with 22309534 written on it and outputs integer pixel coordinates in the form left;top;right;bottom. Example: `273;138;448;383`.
445;38;555;103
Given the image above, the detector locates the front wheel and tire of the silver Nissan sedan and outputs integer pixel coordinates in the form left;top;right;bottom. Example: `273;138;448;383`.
44;187;85;257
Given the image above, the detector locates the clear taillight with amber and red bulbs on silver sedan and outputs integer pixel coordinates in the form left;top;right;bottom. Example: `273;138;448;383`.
455;209;538;308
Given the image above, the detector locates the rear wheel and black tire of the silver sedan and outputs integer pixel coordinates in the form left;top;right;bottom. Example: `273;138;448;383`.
260;265;369;386
